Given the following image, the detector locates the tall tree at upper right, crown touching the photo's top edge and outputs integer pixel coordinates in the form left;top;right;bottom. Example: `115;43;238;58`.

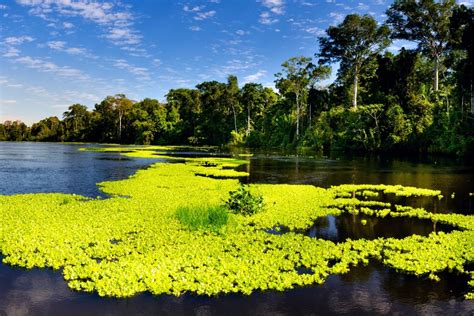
387;0;456;91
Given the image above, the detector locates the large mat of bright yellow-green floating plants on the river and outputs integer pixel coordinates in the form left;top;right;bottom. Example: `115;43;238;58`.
0;147;474;299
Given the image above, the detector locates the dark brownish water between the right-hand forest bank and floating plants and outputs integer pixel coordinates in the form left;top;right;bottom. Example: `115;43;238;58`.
239;155;474;214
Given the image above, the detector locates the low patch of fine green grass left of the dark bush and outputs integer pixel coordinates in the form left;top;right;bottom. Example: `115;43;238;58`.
176;205;229;231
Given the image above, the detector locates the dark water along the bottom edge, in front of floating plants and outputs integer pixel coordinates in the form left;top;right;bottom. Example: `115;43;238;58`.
0;263;474;316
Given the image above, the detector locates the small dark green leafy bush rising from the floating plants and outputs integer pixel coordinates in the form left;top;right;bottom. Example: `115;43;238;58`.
226;185;263;216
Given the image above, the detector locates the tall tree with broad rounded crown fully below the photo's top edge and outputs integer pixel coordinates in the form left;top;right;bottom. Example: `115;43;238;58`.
316;14;390;108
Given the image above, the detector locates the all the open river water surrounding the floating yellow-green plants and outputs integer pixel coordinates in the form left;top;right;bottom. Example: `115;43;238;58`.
0;143;474;316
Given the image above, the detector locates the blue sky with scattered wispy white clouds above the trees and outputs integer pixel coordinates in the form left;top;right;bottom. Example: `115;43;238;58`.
0;0;473;124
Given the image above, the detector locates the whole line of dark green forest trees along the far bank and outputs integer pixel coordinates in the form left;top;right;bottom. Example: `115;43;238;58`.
0;0;474;154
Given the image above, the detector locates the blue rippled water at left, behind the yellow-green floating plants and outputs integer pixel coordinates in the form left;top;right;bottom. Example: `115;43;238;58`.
0;142;157;197
